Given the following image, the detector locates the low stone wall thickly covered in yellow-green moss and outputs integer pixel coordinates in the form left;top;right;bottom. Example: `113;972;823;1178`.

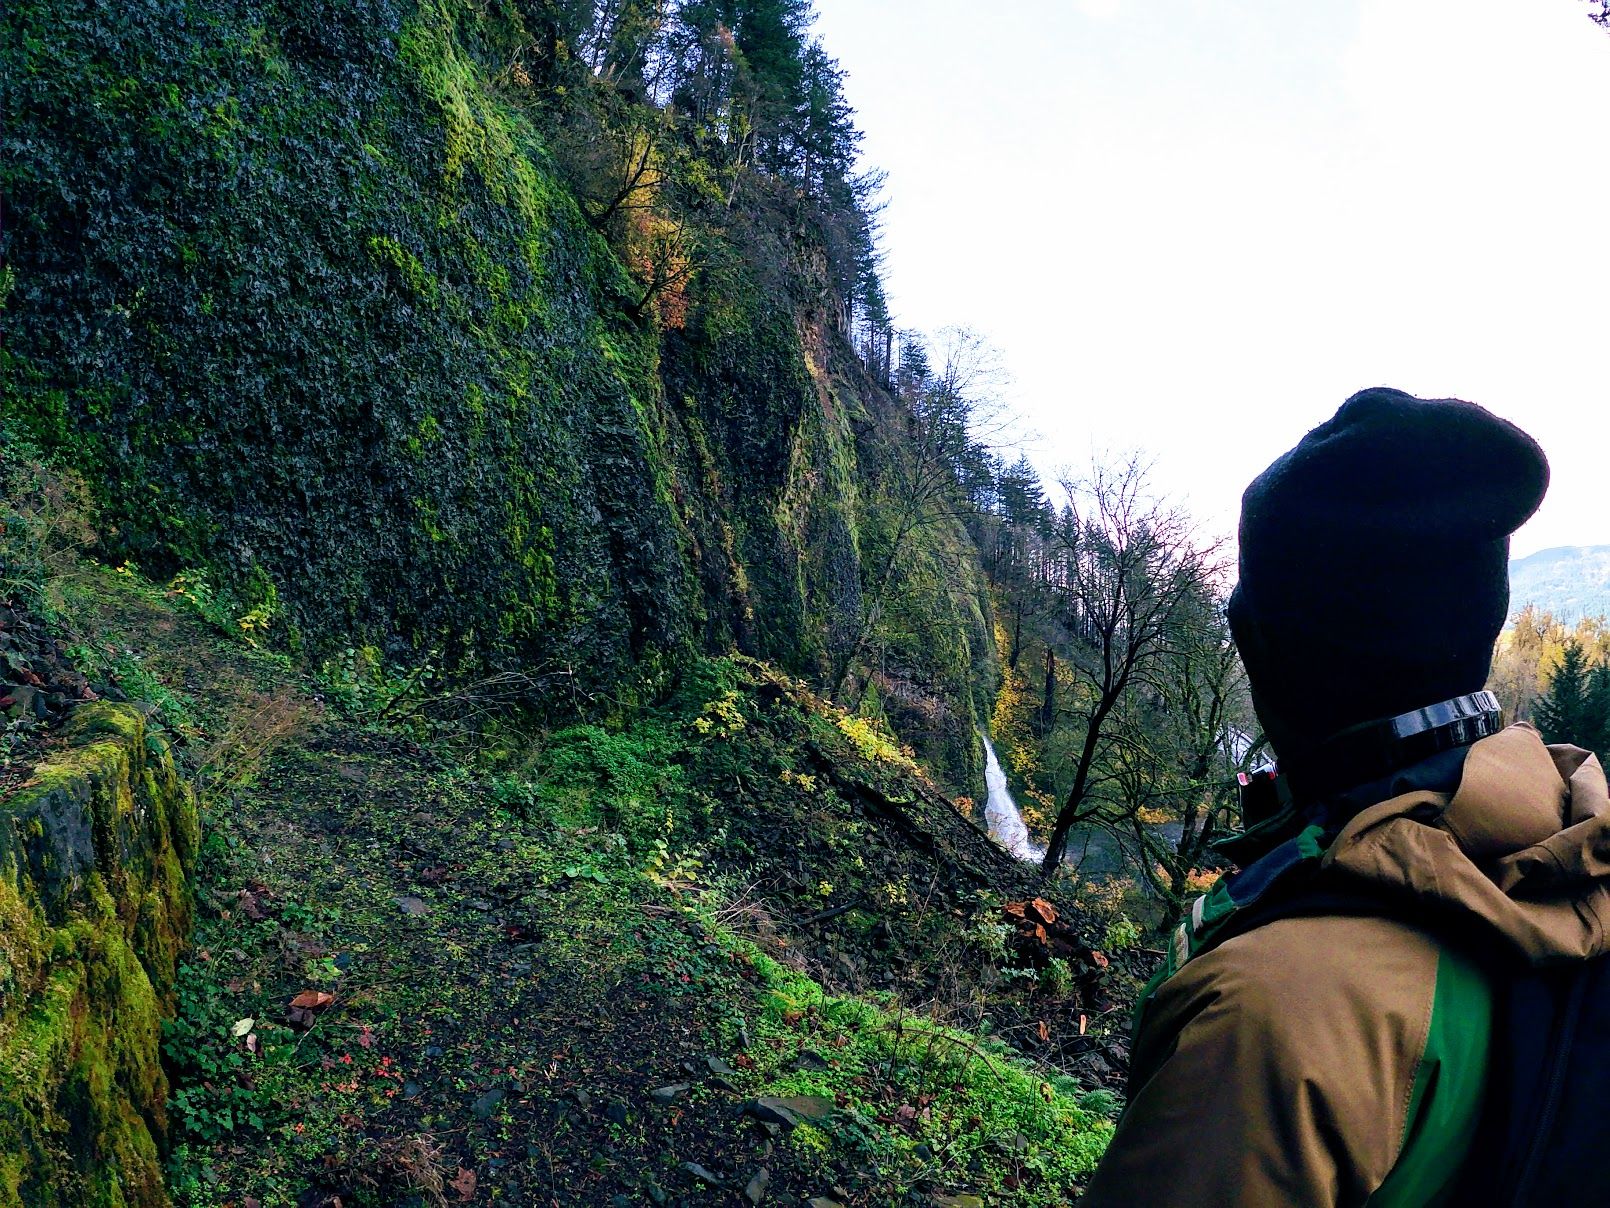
0;704;198;1208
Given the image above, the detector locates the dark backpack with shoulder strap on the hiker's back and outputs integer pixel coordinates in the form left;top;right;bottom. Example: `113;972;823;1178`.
1191;878;1610;1208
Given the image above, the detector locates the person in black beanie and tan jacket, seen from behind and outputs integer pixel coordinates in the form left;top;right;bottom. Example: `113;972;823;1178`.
1080;388;1610;1208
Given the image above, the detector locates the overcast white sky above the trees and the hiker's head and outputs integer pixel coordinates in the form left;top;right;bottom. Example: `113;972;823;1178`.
816;0;1610;554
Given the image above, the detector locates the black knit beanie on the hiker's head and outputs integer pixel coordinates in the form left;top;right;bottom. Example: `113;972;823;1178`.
1230;387;1549;763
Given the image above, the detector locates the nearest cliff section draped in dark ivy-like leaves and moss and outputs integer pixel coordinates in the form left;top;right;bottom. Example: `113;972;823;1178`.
0;0;689;682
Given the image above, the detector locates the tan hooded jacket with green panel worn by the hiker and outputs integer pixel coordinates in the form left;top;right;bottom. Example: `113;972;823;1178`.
1080;725;1610;1208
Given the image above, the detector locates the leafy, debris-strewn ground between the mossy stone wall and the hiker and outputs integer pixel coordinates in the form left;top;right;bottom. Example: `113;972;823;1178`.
53;563;1122;1208
